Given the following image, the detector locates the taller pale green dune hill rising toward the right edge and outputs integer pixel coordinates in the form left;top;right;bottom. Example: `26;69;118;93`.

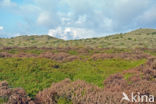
71;29;156;48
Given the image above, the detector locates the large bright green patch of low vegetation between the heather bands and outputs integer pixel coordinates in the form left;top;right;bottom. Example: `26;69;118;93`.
0;58;146;97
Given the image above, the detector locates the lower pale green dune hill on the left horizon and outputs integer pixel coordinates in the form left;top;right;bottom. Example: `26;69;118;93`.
0;35;64;47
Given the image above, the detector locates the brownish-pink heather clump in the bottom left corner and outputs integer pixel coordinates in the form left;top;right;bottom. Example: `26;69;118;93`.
0;81;34;104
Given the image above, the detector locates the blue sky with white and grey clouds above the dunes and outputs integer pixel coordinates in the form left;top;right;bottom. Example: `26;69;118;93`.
0;0;156;40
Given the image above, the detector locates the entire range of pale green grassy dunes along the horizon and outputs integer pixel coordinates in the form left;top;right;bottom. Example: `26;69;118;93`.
0;29;156;48
